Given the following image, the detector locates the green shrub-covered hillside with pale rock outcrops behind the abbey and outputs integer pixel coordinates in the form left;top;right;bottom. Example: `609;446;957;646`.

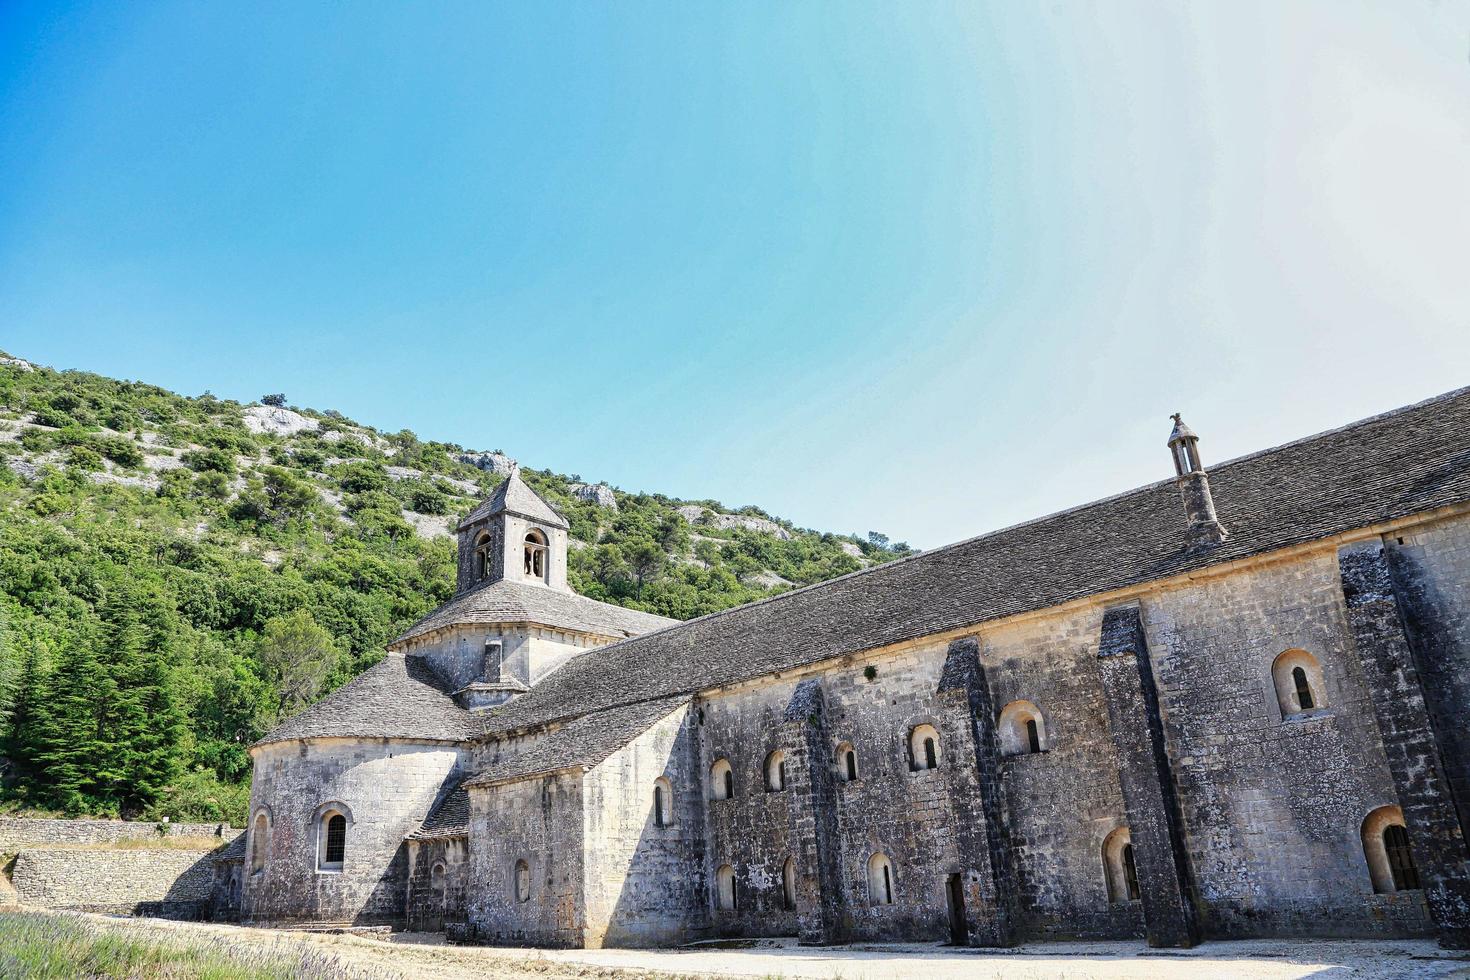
0;354;907;823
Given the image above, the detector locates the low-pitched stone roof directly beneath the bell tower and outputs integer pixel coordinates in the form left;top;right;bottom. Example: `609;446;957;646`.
390;579;679;646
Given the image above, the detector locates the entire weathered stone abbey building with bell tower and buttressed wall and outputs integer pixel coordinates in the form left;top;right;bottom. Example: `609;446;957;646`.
234;388;1470;946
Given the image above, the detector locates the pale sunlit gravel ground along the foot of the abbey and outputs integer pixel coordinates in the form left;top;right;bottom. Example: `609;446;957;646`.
54;915;1470;980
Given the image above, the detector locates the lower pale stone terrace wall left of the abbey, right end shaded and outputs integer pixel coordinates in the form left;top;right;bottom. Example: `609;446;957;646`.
10;848;215;918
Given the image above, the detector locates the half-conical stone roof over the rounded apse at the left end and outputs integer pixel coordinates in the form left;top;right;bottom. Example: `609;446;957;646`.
256;654;478;745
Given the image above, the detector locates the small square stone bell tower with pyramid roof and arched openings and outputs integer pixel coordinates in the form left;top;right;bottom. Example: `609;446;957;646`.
456;466;572;592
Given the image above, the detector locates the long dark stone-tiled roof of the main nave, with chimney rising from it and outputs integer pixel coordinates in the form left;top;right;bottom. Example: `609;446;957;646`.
481;388;1470;735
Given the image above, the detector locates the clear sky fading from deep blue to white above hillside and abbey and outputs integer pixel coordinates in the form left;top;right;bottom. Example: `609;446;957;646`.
0;0;1470;547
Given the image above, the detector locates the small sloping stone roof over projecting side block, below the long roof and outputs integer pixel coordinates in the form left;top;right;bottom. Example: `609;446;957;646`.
465;696;689;786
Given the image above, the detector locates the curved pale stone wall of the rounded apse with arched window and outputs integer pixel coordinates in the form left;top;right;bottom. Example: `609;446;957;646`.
241;739;463;924
